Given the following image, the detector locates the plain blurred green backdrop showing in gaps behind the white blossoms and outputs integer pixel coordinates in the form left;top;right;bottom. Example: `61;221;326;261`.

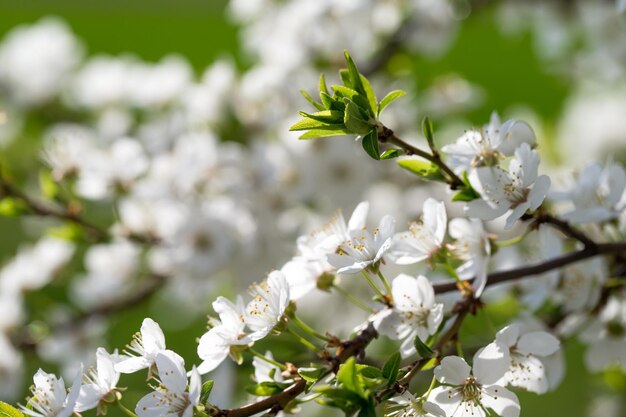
0;0;626;417
